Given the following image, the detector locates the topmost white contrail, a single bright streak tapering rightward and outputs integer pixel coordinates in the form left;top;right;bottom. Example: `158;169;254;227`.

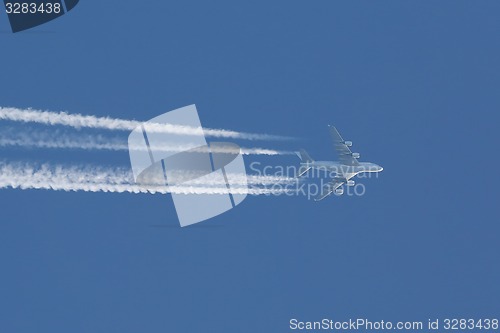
0;107;290;140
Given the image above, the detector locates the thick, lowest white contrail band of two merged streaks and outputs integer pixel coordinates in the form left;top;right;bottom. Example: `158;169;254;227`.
0;162;296;195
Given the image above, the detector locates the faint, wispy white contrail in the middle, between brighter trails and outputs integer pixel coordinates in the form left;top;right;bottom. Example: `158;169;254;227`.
0;131;294;155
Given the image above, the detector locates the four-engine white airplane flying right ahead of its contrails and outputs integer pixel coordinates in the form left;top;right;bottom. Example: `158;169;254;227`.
297;125;384;201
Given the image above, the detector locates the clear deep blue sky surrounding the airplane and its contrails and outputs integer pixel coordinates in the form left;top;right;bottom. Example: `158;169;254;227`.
0;0;500;333
